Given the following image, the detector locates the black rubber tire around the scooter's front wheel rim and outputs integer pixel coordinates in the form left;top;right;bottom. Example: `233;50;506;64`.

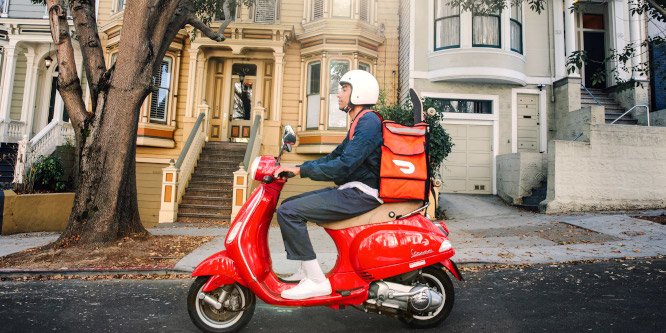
187;276;257;333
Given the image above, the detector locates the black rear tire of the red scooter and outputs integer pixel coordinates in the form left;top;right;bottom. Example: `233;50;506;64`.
400;265;455;329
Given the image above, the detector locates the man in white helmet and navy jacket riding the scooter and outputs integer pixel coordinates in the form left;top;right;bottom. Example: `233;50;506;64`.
274;70;383;300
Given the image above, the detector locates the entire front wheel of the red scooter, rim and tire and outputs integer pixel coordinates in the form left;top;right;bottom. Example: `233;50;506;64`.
187;276;257;333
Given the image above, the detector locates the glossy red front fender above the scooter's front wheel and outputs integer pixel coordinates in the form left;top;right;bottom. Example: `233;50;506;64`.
192;251;245;291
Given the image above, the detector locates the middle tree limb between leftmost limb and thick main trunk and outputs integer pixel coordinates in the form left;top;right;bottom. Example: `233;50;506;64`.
69;0;106;110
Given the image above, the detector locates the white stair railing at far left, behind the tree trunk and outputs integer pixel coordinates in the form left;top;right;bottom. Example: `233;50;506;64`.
14;120;74;184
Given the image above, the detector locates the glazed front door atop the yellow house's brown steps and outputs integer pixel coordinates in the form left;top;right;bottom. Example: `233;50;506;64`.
229;77;255;142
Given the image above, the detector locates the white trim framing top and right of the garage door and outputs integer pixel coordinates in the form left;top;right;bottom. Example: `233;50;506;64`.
421;91;499;195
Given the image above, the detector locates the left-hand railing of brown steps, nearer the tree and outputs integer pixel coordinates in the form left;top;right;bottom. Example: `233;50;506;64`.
158;102;210;223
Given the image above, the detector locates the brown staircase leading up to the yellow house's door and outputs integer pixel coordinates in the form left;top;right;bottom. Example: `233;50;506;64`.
177;142;247;223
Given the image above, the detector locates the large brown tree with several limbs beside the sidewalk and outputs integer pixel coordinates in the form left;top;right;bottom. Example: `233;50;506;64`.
39;0;252;246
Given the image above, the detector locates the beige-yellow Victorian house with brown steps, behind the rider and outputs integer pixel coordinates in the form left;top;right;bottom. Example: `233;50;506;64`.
98;0;398;226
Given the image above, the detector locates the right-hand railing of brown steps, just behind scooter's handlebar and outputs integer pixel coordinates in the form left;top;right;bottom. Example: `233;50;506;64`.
231;106;265;221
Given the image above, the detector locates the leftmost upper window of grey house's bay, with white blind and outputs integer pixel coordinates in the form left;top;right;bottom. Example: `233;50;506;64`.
435;0;460;50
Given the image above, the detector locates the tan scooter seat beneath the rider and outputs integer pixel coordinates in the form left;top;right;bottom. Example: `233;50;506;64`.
321;201;423;230
